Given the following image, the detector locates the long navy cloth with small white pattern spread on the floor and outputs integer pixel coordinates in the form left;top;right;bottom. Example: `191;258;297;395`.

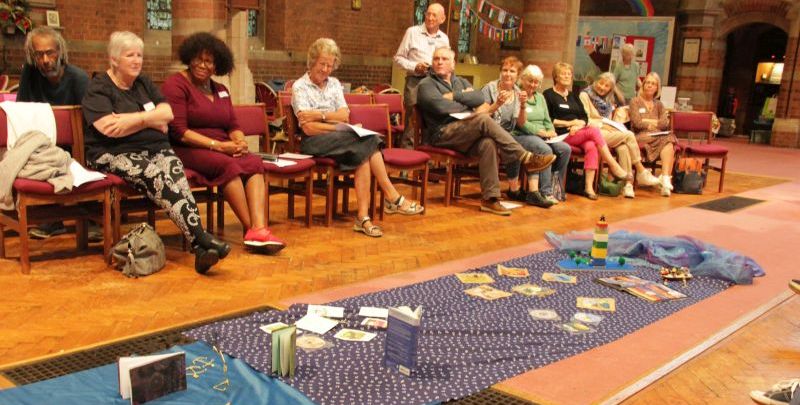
187;251;729;405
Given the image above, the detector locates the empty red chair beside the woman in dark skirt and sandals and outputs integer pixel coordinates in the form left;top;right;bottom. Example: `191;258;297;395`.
350;104;431;219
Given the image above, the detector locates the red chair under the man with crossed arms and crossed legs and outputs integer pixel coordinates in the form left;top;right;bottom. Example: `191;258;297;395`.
414;107;478;207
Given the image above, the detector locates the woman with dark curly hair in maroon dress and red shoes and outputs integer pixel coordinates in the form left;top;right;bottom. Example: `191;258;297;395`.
161;32;286;253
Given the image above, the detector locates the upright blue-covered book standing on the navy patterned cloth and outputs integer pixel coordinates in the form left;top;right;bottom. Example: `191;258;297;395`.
383;306;422;376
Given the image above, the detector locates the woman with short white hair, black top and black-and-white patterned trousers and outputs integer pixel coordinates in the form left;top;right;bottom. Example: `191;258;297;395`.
82;31;231;274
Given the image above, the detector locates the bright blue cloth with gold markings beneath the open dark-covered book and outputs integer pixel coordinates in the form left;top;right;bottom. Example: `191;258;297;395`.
0;342;312;405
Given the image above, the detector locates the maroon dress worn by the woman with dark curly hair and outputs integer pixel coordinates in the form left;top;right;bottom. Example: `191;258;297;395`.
161;73;264;186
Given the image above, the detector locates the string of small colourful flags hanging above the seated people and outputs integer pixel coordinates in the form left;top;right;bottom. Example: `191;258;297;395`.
456;0;523;41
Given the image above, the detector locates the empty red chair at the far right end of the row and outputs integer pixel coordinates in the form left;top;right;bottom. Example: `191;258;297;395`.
670;111;728;193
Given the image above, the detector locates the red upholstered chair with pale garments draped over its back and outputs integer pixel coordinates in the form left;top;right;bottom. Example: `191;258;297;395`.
0;106;111;274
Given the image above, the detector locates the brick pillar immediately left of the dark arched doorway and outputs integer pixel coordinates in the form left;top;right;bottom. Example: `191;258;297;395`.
672;0;726;111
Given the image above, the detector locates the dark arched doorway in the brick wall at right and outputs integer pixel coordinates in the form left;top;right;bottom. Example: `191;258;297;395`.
717;23;788;136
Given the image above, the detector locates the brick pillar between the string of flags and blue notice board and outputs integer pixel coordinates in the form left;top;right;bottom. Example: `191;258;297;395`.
522;0;581;88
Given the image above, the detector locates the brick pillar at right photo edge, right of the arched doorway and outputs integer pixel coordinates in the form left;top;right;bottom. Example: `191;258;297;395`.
770;16;800;148
